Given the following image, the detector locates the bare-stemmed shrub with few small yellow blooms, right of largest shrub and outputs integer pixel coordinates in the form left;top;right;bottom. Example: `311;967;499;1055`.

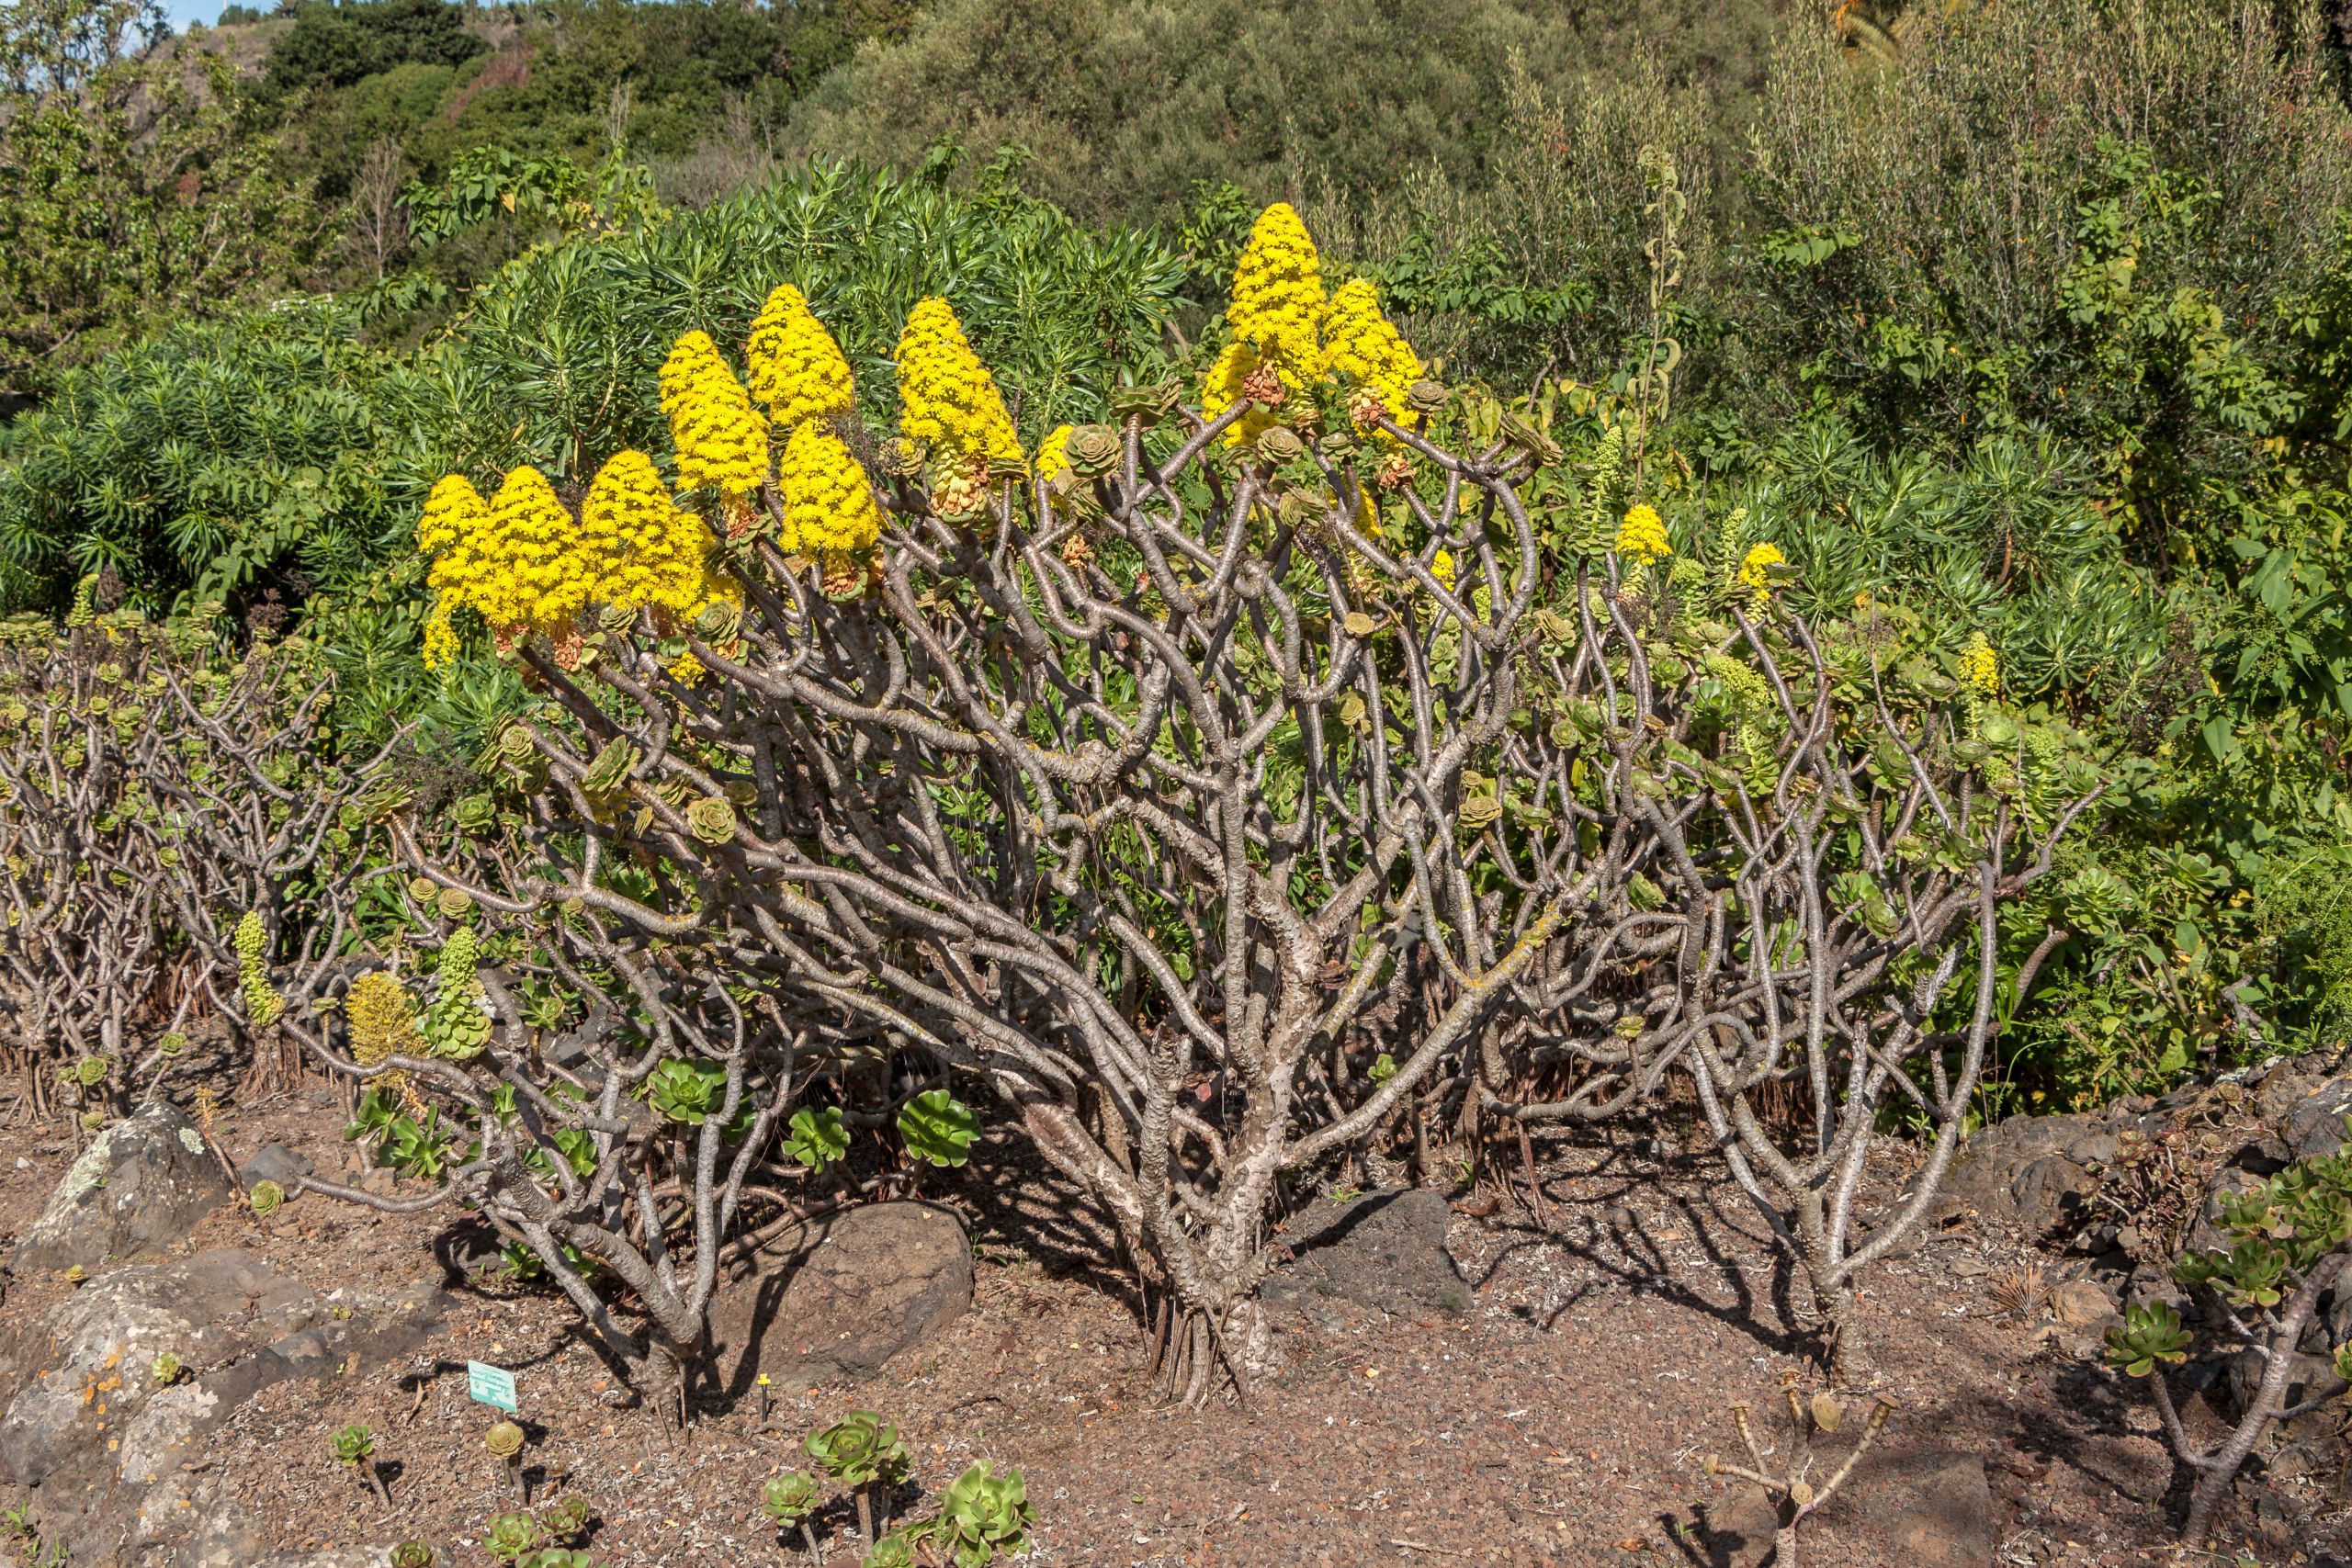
1475;524;2100;1373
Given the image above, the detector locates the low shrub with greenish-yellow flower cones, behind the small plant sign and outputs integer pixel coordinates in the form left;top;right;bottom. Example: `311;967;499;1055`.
285;879;814;1416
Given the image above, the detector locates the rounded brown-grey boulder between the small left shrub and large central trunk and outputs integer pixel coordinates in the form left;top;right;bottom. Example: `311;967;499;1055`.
710;1203;971;1394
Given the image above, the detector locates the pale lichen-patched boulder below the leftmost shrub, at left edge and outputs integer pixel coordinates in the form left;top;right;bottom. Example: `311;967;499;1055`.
9;1102;228;1272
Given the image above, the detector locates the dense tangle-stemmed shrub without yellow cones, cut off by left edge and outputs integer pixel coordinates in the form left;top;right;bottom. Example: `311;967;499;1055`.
0;597;371;1102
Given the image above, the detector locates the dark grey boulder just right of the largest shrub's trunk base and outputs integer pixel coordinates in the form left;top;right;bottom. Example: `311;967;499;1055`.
1263;1187;1470;1316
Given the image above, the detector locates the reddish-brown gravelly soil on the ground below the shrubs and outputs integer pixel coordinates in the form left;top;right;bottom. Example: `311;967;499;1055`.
0;1090;2345;1568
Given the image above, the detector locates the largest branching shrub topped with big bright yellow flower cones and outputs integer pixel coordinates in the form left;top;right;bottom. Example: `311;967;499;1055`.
395;209;1557;1399
